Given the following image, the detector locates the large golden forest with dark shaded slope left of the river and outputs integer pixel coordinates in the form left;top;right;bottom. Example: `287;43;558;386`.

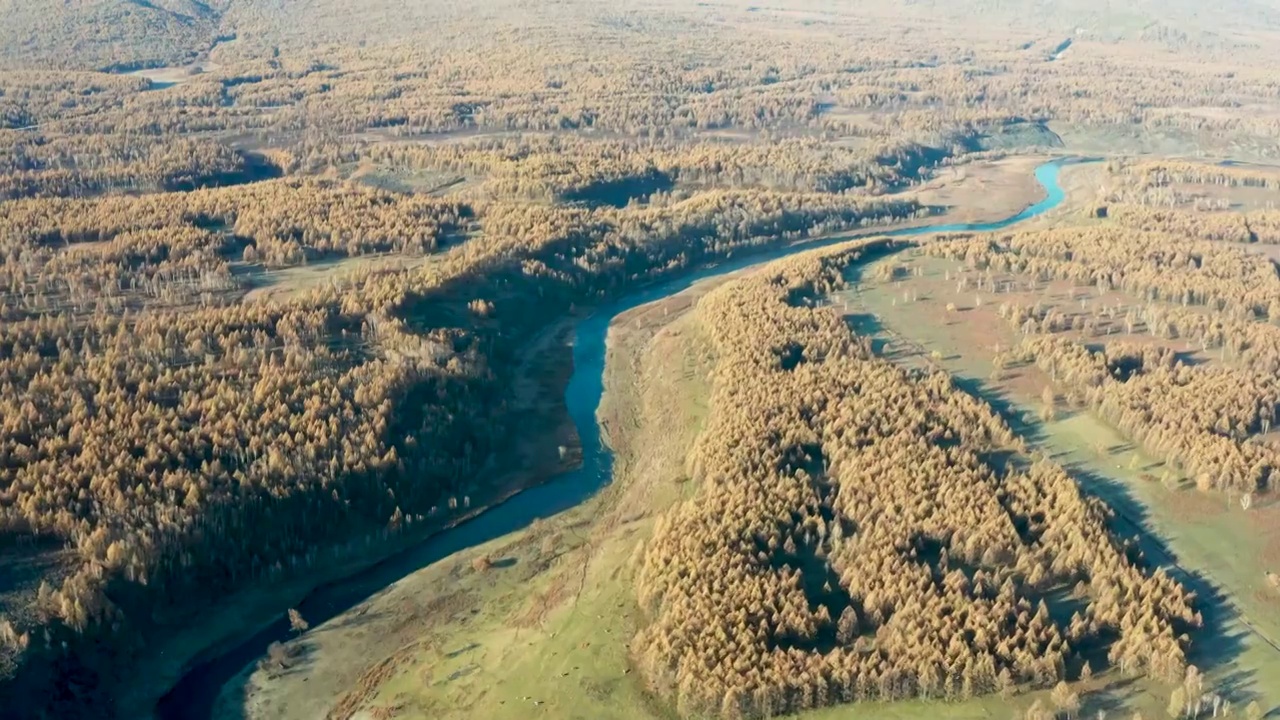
0;114;929;716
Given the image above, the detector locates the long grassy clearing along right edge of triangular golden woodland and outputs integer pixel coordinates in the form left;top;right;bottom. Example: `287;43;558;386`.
836;248;1280;712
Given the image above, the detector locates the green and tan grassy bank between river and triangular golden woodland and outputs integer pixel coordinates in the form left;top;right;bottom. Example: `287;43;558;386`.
369;307;710;720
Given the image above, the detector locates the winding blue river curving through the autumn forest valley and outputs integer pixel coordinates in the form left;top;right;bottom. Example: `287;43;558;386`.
156;159;1076;720
